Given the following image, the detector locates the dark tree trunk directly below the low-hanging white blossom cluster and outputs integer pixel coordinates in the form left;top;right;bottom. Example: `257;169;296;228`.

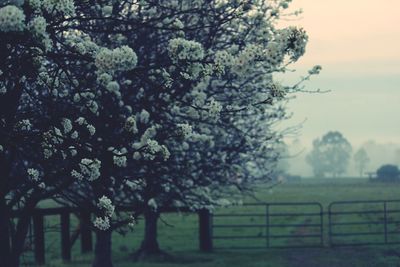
92;230;113;267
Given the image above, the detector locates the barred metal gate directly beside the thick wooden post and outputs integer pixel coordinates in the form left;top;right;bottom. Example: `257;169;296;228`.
212;202;324;249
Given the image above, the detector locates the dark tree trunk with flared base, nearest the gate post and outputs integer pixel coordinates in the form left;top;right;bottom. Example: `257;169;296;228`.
139;208;161;255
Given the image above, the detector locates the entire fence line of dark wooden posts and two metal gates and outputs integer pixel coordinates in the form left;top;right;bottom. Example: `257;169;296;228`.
13;200;400;264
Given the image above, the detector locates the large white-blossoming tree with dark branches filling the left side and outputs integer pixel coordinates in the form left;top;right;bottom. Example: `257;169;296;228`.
0;0;319;267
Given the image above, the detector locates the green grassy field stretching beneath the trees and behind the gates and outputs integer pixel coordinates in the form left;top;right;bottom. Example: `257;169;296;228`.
24;178;400;267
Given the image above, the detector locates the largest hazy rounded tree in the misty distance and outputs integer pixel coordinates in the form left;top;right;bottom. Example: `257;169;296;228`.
306;131;352;177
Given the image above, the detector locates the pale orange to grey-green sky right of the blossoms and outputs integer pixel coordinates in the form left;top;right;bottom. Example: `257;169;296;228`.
279;0;400;147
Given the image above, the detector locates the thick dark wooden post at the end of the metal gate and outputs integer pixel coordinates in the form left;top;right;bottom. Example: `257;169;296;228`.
198;209;213;252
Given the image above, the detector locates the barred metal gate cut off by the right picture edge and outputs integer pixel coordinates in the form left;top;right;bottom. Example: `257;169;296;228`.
328;200;400;246
